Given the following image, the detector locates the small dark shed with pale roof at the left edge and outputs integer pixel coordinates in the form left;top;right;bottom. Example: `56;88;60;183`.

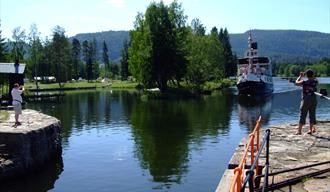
0;63;26;95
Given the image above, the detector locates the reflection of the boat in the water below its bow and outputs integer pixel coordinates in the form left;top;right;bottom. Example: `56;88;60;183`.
237;95;272;130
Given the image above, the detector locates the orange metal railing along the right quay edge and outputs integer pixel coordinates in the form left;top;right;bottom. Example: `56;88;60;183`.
230;116;261;192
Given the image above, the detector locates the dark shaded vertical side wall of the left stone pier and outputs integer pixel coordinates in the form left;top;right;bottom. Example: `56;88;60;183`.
0;111;62;180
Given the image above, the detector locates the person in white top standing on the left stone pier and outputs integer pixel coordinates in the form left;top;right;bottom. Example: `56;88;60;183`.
11;83;24;126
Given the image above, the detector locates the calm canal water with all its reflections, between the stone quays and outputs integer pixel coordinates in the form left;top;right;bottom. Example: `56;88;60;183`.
0;78;330;192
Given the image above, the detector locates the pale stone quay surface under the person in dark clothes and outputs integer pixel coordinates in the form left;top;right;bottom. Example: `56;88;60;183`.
216;120;330;192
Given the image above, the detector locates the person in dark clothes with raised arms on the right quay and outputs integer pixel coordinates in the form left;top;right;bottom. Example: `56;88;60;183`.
295;69;318;135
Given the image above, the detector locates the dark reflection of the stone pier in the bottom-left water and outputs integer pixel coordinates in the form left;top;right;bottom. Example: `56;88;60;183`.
0;155;63;192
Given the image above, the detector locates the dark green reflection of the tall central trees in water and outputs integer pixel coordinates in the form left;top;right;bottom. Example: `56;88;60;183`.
123;91;232;187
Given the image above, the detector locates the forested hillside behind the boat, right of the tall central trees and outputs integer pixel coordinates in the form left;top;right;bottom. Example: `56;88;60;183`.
230;30;330;62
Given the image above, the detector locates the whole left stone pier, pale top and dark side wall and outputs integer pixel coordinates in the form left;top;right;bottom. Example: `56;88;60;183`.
0;109;62;180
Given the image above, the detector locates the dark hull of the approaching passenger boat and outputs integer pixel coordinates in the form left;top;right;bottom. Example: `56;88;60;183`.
237;81;274;95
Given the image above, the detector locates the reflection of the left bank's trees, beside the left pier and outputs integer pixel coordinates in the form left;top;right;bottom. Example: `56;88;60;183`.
28;90;113;147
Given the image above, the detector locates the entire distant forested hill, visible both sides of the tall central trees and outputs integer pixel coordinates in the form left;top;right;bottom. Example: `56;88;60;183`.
72;30;330;62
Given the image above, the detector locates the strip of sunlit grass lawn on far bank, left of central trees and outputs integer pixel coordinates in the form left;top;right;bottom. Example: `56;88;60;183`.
24;80;137;89
